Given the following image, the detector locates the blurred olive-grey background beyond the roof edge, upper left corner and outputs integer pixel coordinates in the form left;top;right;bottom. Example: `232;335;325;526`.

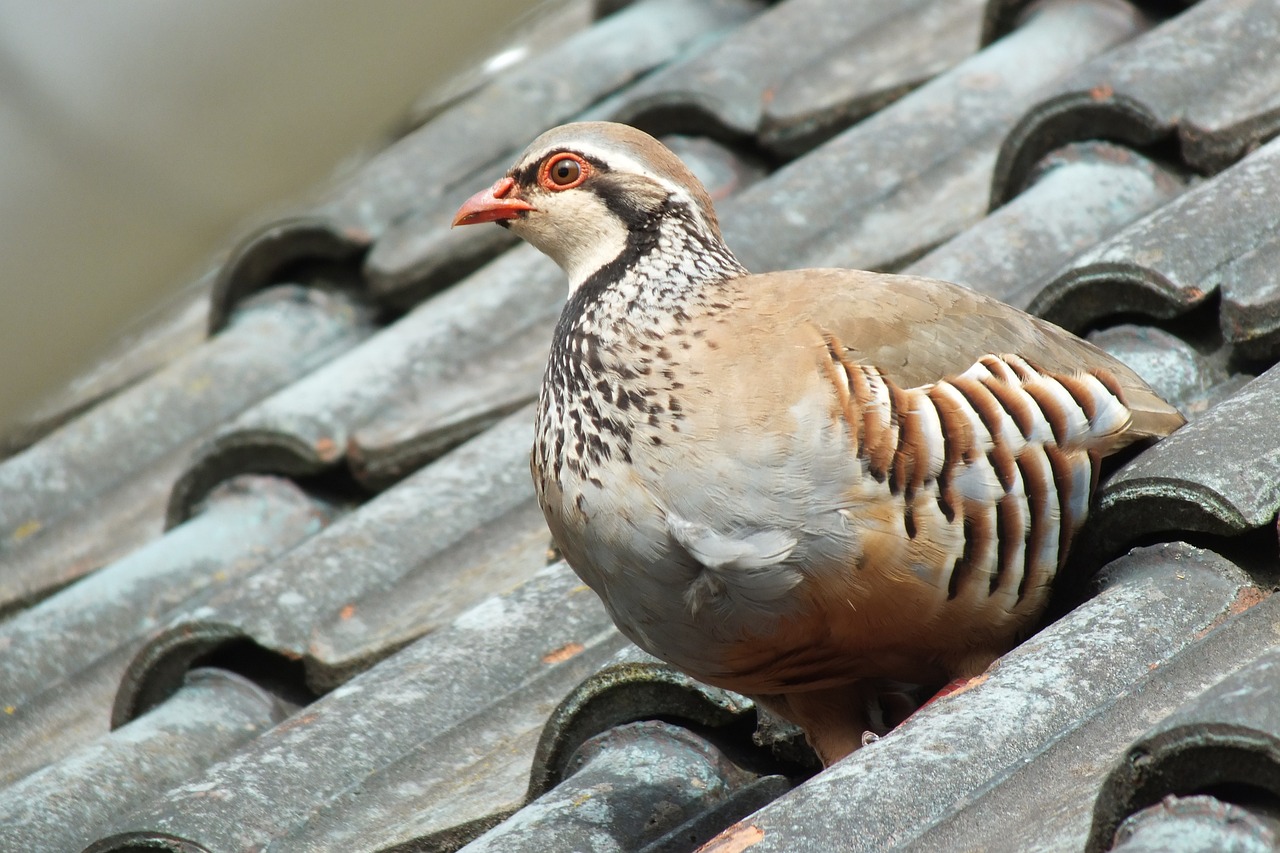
0;0;570;424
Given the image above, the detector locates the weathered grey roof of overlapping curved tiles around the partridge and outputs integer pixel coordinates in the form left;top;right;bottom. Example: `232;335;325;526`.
0;0;1280;852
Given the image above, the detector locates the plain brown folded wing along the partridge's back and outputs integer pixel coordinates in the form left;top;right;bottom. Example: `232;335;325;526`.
741;269;1185;439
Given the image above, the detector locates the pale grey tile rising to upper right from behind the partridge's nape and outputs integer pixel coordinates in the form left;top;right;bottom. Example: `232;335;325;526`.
719;0;1143;272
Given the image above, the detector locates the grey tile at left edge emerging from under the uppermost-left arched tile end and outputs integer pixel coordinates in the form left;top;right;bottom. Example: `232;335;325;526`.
0;287;371;606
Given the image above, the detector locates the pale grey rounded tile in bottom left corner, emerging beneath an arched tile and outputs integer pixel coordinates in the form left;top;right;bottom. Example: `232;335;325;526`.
0;670;284;850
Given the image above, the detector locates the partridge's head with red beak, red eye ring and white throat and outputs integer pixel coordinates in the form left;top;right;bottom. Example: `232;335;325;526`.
453;122;721;287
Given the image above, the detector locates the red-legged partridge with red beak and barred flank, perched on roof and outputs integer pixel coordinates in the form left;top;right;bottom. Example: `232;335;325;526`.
453;122;1185;766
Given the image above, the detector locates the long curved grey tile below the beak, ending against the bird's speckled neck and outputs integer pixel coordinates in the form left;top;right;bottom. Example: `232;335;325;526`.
169;246;566;520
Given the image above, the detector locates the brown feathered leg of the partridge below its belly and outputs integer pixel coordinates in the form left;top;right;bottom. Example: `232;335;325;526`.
755;680;915;767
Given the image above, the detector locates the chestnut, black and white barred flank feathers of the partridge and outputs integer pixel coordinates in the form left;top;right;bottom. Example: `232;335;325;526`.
827;337;1140;608
